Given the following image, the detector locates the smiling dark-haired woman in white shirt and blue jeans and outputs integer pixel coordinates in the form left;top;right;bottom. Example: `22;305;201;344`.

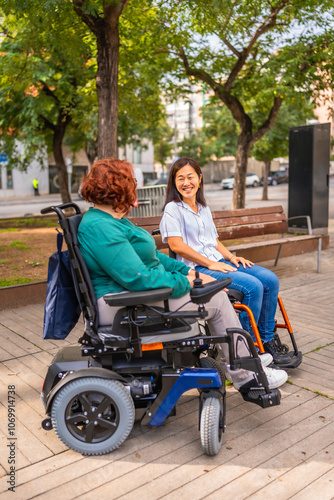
160;157;290;365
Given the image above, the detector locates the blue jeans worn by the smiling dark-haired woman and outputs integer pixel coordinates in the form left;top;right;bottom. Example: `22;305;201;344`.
195;259;279;342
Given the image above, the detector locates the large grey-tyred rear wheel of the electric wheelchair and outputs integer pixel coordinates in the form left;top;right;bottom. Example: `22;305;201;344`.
51;377;135;455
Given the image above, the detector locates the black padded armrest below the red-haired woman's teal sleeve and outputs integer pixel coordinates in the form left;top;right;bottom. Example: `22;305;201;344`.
103;287;173;307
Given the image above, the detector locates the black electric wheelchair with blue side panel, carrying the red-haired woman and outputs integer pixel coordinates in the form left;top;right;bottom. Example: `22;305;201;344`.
41;203;280;455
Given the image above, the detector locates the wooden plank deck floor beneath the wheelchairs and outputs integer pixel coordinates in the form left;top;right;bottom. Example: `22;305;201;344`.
0;240;334;500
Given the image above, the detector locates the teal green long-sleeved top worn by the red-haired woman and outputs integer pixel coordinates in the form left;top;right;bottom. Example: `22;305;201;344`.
78;208;190;298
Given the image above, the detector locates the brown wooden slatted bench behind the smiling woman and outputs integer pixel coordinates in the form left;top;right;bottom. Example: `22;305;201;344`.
131;206;321;273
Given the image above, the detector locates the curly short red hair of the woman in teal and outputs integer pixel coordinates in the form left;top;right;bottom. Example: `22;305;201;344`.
81;158;137;214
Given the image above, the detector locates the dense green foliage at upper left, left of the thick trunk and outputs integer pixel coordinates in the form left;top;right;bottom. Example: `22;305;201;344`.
0;9;95;169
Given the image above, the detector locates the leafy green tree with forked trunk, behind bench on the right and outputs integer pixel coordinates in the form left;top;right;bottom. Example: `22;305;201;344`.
155;0;334;208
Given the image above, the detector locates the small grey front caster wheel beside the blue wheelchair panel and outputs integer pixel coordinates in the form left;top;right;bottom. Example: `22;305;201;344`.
200;398;224;456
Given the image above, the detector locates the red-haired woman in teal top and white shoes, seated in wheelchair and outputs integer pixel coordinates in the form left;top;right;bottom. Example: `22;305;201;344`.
78;159;287;392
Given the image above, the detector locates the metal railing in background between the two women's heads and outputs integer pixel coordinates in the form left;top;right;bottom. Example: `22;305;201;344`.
129;185;166;217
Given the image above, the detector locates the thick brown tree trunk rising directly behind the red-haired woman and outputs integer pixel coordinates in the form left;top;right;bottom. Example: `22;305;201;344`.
96;19;119;159
